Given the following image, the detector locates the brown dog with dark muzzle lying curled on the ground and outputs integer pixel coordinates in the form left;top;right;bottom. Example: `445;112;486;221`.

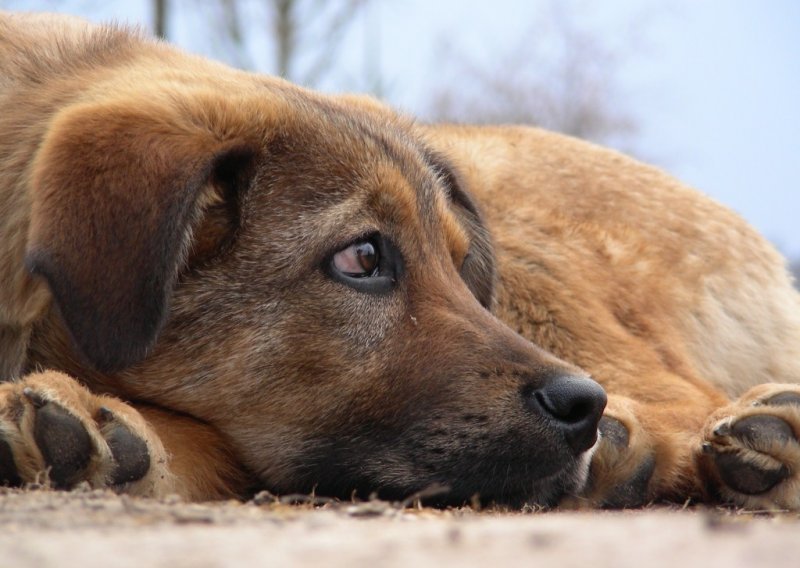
0;14;800;509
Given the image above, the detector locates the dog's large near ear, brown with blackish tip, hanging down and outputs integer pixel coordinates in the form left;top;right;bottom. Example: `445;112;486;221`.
25;104;254;371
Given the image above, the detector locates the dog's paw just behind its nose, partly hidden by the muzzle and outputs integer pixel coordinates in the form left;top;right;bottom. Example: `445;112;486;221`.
565;397;656;509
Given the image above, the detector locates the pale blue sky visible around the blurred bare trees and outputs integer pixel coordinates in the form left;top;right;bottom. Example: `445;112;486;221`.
12;0;800;258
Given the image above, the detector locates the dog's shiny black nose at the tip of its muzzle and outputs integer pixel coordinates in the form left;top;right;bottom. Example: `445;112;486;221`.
527;376;607;453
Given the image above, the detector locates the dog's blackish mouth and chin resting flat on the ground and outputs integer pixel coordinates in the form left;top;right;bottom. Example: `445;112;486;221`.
265;424;598;509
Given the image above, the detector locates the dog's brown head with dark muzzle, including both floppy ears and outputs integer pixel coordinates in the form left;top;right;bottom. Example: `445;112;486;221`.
27;76;605;504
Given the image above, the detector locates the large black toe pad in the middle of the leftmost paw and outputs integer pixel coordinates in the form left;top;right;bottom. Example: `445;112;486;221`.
33;402;93;489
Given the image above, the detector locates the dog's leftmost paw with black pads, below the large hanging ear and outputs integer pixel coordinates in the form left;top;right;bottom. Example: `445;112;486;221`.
0;372;171;495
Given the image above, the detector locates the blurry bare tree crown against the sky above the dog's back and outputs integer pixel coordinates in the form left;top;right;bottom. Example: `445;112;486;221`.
429;2;636;151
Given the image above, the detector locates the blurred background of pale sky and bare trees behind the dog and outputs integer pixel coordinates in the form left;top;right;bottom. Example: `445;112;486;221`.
6;0;800;276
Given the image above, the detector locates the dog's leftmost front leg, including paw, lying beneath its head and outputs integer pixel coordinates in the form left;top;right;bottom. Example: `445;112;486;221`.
0;371;247;499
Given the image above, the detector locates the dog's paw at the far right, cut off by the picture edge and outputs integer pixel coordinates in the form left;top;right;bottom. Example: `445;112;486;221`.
701;384;800;510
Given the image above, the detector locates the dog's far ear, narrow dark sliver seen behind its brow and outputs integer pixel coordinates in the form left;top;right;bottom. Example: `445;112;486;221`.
427;152;496;309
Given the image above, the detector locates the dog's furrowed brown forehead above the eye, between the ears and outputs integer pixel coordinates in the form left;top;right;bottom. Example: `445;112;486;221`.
241;99;469;264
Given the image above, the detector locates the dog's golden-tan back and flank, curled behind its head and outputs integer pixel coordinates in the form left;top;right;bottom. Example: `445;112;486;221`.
428;126;800;396
